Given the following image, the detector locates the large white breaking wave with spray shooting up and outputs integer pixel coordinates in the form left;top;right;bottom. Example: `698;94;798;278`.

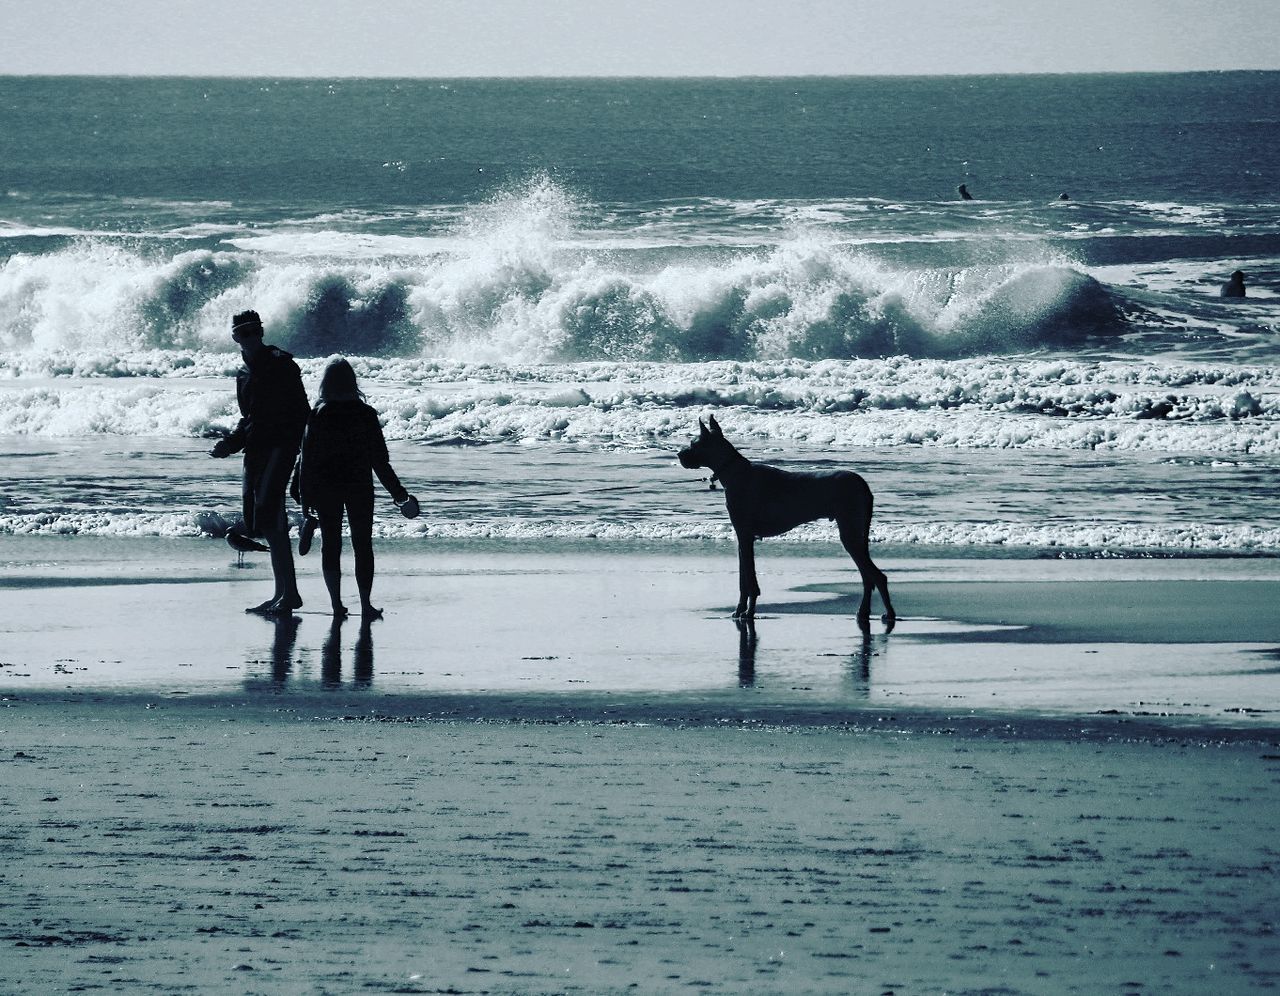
0;181;1128;362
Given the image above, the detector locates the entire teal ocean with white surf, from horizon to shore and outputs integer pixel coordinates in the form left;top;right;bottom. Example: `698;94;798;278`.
0;72;1280;558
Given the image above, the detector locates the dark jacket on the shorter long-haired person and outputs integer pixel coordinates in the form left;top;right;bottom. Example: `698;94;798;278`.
298;401;408;508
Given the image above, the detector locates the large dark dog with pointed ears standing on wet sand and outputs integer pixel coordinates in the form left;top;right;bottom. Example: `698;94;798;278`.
677;416;897;630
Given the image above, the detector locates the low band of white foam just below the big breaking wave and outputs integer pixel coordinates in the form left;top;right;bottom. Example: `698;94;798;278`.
0;351;1280;454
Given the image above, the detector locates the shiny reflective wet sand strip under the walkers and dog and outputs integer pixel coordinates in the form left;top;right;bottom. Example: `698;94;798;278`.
0;542;1280;736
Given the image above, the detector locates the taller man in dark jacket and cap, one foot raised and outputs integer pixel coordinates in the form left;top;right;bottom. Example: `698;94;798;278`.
210;311;311;616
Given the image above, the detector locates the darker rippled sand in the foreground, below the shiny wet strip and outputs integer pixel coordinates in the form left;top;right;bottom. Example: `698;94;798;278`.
0;699;1280;993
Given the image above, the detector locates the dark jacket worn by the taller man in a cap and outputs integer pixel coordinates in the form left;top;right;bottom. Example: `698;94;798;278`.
224;346;311;453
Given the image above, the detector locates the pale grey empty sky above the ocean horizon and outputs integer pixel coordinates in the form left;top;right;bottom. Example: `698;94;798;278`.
0;0;1280;77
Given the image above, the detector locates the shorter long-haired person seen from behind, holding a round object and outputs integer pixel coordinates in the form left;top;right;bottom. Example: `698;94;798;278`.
297;356;417;620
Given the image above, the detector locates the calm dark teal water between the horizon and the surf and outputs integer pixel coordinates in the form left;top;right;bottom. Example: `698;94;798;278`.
0;73;1280;206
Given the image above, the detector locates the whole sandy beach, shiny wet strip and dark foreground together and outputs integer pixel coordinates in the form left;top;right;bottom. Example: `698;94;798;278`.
0;540;1280;993
